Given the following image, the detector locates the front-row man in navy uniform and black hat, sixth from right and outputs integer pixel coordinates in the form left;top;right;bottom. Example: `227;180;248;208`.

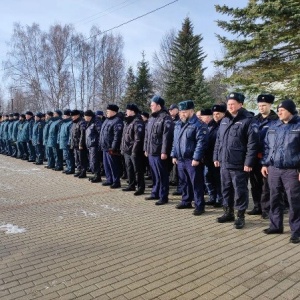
100;104;123;189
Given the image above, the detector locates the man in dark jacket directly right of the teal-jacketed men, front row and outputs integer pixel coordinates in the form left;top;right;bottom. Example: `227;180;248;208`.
70;109;88;178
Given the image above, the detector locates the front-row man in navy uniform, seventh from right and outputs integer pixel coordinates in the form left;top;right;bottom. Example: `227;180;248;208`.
84;109;103;183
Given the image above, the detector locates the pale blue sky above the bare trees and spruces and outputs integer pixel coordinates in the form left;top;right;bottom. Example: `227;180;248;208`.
0;0;247;83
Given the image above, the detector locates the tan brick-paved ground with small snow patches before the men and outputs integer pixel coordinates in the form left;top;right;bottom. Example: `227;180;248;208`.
0;156;300;300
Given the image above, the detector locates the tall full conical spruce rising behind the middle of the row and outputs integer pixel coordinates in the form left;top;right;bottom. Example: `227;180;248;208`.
166;18;207;106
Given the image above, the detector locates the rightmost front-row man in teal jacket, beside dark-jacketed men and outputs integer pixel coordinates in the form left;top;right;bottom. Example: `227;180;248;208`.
58;109;75;175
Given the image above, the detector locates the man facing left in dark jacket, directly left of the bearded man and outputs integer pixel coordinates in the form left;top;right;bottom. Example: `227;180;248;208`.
144;95;174;205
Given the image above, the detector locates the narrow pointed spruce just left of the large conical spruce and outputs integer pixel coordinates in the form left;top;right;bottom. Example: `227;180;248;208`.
136;52;153;110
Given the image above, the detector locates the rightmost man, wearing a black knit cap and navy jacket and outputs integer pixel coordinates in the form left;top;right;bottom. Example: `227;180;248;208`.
261;99;300;244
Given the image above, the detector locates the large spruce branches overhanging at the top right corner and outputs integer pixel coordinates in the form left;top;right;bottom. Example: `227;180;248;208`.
216;0;300;101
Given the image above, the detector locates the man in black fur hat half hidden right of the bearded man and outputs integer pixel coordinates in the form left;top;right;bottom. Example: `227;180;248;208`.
205;104;226;207
